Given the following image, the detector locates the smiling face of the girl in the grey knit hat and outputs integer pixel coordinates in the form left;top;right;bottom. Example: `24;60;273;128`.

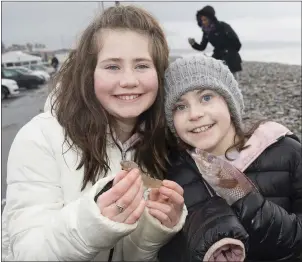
173;90;235;154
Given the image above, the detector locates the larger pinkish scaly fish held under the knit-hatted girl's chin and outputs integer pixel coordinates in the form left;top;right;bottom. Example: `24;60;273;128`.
190;149;257;204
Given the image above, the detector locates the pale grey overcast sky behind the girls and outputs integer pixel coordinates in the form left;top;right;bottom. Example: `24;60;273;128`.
2;2;301;49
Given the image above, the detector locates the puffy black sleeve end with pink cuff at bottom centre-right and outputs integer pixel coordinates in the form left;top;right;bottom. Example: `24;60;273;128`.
183;196;249;262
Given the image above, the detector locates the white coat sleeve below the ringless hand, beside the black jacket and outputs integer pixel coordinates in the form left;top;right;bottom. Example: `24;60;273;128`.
123;194;188;261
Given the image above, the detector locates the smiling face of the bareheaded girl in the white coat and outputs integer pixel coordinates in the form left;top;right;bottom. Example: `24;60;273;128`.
94;30;158;123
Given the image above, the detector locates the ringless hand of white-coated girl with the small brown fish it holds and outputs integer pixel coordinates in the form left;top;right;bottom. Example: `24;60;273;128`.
121;161;184;228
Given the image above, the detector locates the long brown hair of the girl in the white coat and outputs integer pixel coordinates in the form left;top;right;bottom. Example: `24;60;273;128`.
51;5;169;190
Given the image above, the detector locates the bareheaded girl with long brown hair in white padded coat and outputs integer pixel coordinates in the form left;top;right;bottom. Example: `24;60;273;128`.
2;6;187;261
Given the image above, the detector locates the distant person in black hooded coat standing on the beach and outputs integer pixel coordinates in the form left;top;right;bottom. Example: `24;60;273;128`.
188;5;242;80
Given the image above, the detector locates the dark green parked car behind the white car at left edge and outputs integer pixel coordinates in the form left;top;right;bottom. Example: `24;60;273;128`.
1;68;45;88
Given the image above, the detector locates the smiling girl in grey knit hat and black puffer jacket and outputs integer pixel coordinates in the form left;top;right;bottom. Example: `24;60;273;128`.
159;55;302;261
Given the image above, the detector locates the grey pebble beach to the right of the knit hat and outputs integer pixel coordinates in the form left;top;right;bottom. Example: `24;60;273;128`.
239;62;302;140
